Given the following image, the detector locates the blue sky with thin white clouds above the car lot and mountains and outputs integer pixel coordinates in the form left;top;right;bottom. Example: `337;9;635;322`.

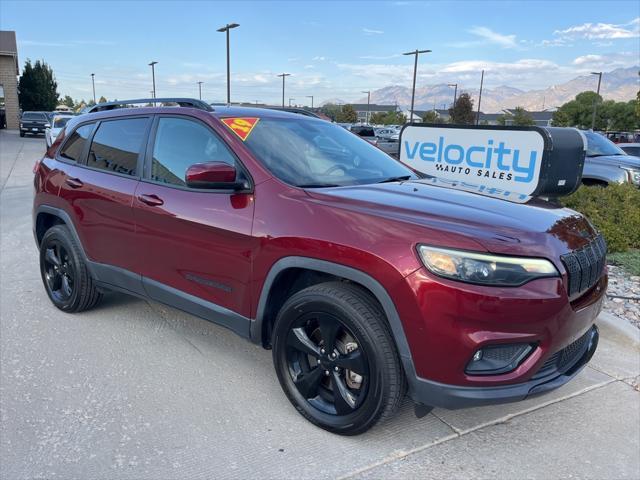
0;0;640;104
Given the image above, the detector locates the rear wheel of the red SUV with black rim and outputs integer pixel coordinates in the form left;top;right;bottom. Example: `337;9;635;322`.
40;225;102;313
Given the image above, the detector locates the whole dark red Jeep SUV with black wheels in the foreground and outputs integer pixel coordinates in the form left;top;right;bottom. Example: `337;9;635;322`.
33;99;607;435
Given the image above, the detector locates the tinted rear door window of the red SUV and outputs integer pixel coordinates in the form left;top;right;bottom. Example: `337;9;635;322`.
87;118;149;176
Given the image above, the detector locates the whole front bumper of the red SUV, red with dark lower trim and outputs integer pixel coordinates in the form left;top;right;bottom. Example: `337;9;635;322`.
395;269;607;409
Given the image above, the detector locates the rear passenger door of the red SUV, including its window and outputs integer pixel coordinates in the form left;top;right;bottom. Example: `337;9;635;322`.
60;117;151;292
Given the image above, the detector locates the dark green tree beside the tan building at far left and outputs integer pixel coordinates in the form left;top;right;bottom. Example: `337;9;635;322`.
18;59;58;111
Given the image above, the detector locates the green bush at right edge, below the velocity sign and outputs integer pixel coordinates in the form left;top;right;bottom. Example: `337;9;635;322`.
561;183;640;252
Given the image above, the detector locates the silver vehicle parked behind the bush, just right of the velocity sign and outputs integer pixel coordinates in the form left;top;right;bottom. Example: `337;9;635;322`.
582;131;640;186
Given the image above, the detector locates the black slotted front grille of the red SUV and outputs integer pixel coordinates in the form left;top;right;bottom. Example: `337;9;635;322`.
560;235;607;297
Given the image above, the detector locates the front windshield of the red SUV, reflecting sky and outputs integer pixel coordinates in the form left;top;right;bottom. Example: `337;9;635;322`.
240;118;417;187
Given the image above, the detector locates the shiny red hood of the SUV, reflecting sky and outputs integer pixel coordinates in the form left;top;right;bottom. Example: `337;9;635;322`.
308;180;596;259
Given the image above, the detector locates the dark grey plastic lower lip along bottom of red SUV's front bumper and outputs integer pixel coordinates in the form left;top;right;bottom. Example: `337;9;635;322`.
412;325;599;409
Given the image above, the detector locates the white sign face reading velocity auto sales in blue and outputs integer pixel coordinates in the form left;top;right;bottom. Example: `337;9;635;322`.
400;124;545;199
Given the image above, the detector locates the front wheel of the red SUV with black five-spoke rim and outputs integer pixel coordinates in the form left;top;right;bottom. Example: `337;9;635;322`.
272;282;406;435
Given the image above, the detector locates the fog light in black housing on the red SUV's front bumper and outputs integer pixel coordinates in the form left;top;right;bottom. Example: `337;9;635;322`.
465;343;534;375
